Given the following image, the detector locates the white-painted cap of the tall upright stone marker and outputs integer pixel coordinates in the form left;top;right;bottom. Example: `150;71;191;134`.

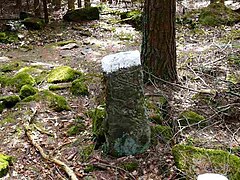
102;50;141;73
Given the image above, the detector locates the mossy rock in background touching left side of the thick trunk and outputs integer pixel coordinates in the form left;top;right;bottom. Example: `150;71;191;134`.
120;10;143;30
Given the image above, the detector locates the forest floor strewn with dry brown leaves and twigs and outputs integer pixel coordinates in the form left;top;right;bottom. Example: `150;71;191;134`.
0;1;240;180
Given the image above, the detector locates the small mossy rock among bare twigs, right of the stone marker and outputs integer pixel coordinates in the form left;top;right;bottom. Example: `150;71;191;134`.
179;110;205;126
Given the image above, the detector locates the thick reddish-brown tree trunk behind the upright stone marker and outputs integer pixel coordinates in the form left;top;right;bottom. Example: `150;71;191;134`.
141;0;177;82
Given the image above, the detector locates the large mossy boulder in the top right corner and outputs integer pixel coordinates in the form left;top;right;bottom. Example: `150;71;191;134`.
199;2;240;26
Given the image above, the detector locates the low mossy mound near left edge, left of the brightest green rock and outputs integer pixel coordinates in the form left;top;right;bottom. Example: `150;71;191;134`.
7;72;35;91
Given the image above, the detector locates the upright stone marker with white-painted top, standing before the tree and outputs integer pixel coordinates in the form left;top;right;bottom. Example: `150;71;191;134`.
102;51;150;157
